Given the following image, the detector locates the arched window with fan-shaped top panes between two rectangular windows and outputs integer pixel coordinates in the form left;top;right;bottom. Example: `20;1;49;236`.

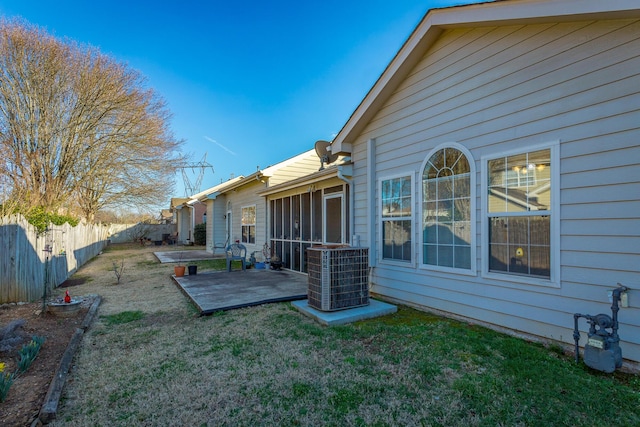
422;146;475;270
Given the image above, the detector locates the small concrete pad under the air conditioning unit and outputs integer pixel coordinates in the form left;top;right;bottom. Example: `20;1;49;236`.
291;299;398;326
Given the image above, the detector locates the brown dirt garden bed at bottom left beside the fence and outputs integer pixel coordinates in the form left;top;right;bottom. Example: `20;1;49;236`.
0;298;93;426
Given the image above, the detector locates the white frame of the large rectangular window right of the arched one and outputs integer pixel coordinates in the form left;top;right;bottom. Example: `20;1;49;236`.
481;140;560;288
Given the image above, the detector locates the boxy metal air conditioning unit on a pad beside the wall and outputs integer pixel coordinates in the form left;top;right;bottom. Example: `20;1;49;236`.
307;246;369;311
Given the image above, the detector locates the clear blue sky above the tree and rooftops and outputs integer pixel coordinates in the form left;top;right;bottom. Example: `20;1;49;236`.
0;0;476;200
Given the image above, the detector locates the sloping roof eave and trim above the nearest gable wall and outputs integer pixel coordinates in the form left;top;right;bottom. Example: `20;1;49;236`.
331;0;640;154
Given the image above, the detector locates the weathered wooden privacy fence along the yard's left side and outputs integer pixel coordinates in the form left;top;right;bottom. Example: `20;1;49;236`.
0;215;108;304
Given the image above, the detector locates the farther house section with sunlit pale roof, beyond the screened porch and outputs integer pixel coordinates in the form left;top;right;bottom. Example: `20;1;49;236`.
197;150;320;264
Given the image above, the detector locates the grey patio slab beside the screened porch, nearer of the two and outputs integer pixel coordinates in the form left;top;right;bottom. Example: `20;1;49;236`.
173;269;307;315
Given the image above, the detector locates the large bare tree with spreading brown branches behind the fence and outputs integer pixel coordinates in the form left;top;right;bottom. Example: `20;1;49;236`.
0;20;184;220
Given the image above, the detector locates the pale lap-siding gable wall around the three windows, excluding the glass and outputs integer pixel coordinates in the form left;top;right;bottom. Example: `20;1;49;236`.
352;20;640;362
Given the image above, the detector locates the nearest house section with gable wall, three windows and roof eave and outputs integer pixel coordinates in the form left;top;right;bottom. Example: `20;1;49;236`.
328;0;640;362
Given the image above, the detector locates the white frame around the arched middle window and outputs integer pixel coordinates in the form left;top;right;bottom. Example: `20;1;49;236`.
416;142;478;276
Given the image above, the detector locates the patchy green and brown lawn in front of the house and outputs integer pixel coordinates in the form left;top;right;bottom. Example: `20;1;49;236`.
47;247;640;426
